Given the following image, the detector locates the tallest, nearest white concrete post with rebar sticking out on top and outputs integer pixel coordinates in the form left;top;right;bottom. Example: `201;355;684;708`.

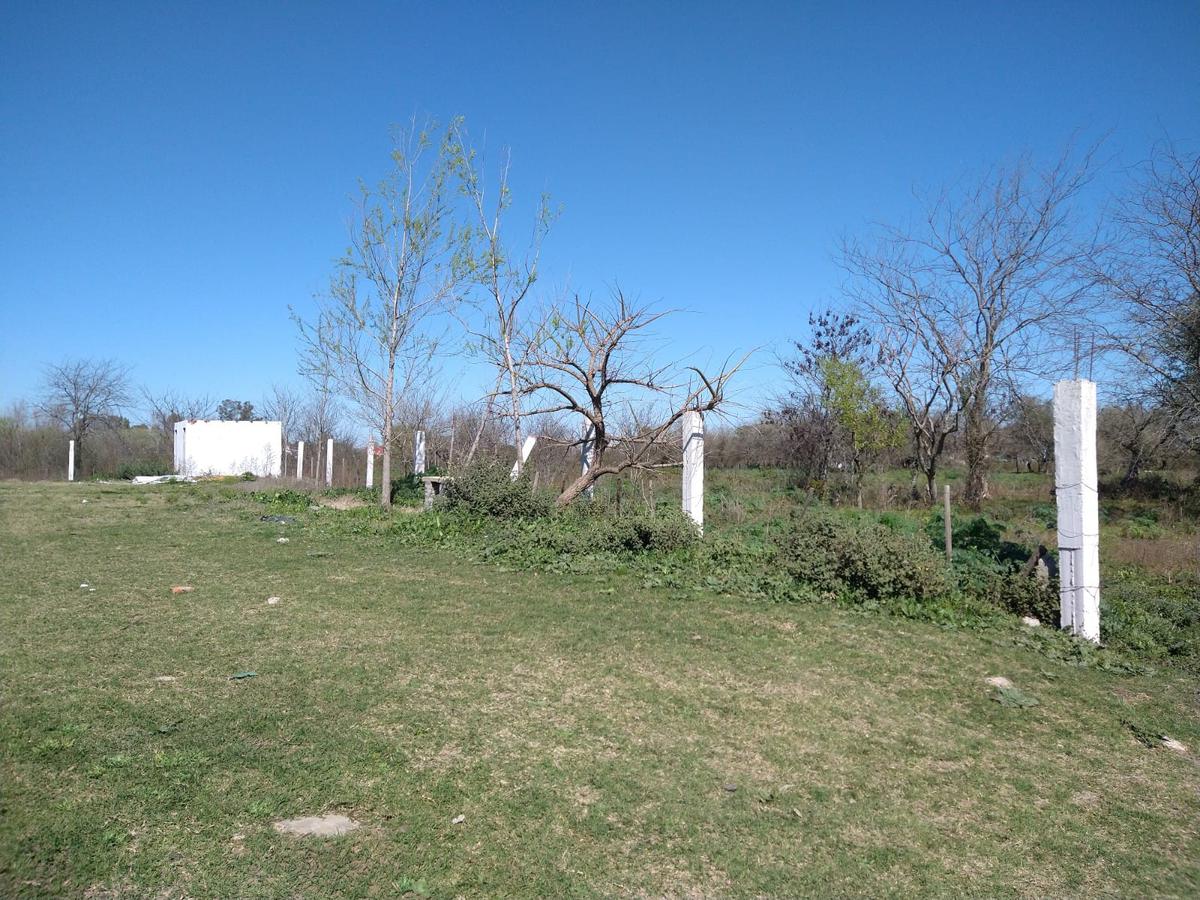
1054;380;1100;643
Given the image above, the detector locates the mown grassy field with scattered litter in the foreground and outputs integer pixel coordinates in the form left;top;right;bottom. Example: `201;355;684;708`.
0;484;1200;898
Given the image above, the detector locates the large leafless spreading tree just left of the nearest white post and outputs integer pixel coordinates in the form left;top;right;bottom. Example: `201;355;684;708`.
842;154;1094;508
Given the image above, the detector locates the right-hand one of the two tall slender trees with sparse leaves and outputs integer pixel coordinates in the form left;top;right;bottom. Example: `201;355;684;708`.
455;126;554;473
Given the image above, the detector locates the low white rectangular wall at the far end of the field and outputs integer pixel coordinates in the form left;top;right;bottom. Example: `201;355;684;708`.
175;419;283;476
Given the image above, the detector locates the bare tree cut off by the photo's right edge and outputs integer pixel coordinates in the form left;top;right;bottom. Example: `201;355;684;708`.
1096;144;1200;446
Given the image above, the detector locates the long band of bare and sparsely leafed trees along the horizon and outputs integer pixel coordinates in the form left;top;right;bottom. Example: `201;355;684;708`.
0;127;1200;506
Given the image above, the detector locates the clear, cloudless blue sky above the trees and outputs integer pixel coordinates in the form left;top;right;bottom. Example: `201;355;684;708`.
0;0;1200;422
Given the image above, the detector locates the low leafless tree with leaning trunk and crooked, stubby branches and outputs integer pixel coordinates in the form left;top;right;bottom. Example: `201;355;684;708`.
518;290;745;506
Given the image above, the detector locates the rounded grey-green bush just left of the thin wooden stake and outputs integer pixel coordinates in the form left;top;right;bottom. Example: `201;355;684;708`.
776;510;953;602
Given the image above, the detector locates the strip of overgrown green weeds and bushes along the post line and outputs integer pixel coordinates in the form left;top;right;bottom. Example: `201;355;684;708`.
248;461;1200;671
